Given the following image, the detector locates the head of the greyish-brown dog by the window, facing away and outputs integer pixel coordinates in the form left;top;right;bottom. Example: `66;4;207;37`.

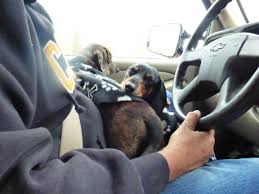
81;44;119;75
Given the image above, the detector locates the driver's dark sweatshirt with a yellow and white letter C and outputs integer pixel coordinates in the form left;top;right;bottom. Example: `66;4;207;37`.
0;0;169;194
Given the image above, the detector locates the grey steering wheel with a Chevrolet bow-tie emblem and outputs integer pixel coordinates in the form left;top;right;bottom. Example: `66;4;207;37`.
173;0;259;130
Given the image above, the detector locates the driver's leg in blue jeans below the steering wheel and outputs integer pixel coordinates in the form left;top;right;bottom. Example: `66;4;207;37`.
161;158;259;194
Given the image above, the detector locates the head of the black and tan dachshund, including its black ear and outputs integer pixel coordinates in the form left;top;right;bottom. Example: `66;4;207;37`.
121;64;167;117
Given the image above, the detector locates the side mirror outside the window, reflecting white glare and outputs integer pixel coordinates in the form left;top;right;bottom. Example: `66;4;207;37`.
147;23;190;57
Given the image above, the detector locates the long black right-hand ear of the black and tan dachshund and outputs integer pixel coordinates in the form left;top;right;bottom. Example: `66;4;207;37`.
149;79;167;116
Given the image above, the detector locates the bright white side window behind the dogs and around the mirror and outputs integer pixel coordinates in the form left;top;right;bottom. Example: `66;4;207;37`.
39;0;205;58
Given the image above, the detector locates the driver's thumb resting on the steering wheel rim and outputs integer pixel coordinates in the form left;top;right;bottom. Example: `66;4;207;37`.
181;110;201;131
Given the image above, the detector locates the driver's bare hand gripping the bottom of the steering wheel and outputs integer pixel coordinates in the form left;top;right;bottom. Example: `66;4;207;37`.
159;111;215;181
